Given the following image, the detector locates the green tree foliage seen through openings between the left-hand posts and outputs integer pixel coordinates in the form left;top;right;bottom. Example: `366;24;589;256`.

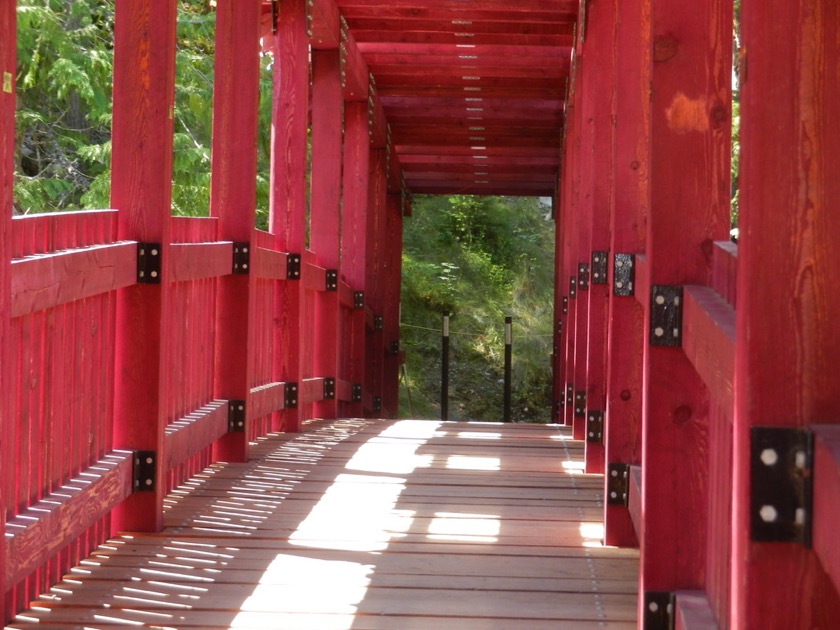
15;0;271;227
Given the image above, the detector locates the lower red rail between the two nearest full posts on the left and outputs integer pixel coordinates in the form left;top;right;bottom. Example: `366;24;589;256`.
164;400;228;470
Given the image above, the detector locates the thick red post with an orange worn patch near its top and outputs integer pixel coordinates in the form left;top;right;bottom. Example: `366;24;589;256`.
640;0;732;618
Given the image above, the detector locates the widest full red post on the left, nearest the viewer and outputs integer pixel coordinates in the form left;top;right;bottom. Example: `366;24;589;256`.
111;0;176;531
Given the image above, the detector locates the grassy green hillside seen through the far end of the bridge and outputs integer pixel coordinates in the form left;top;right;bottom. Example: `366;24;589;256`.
400;196;554;422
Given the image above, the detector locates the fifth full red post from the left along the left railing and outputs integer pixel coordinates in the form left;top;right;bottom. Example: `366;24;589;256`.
341;101;371;417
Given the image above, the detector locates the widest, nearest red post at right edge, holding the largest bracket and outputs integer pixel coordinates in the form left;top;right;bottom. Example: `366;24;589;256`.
730;0;840;628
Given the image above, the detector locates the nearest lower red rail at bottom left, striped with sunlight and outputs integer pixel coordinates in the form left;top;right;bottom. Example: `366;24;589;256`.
5;451;134;587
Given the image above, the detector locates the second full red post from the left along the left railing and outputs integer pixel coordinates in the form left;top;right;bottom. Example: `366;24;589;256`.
210;0;260;461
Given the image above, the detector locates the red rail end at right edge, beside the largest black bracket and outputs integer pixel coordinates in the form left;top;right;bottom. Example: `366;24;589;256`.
811;425;840;591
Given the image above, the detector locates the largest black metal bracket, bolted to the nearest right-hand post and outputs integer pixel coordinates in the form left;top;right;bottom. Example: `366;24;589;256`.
750;427;814;547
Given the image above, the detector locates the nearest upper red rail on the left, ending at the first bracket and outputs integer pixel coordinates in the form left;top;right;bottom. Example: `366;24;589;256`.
12;242;137;317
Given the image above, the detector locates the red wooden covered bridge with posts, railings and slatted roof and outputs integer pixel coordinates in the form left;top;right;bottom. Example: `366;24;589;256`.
0;0;840;630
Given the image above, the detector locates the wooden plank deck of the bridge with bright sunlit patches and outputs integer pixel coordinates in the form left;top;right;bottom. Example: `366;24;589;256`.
10;420;638;630
